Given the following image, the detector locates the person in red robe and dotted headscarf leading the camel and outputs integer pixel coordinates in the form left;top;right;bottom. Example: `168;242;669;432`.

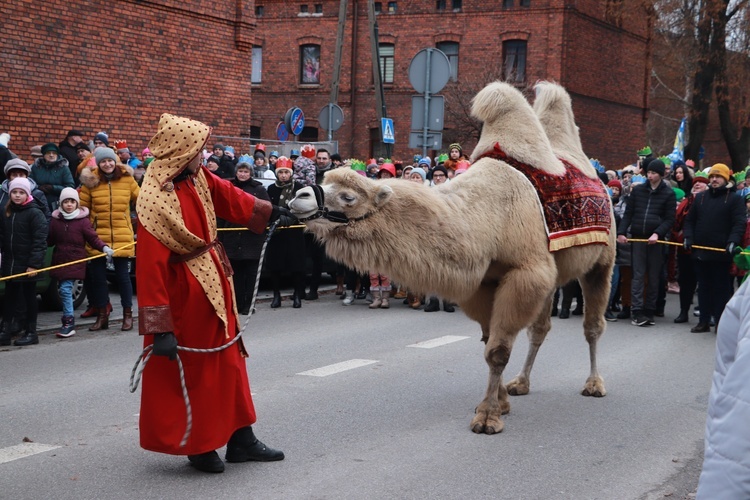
137;114;293;472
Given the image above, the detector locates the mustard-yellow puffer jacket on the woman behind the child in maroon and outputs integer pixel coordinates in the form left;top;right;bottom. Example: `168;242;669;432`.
80;163;140;257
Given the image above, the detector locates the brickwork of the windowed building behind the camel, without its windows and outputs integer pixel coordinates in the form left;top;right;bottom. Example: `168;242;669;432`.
253;0;646;165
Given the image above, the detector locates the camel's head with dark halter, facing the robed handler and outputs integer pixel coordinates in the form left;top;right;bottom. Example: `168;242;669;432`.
289;168;393;237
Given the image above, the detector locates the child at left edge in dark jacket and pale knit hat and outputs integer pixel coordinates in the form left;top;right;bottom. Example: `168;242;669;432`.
0;178;48;346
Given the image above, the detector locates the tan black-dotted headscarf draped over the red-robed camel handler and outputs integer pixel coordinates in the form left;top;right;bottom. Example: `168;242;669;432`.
136;113;238;338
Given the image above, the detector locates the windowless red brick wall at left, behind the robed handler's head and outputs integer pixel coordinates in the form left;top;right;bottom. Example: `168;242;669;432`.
0;0;255;159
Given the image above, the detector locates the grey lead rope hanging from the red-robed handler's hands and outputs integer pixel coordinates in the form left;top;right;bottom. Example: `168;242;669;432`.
130;220;279;447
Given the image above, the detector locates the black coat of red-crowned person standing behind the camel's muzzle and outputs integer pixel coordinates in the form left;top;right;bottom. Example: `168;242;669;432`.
264;182;305;274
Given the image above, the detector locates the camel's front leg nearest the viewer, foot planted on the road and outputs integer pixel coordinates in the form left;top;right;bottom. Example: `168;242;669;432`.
471;265;554;434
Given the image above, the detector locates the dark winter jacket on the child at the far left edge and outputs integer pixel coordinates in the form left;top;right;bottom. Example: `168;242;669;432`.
0;197;48;281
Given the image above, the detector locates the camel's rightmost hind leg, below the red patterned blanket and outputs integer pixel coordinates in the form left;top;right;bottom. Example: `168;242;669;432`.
579;264;612;398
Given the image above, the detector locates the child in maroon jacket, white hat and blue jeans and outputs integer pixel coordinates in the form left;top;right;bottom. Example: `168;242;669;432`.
47;188;115;338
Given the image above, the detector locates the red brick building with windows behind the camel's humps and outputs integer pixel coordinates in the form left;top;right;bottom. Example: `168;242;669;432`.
252;0;650;167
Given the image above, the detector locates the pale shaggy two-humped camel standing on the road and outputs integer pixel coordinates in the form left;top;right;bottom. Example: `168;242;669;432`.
289;82;616;434
